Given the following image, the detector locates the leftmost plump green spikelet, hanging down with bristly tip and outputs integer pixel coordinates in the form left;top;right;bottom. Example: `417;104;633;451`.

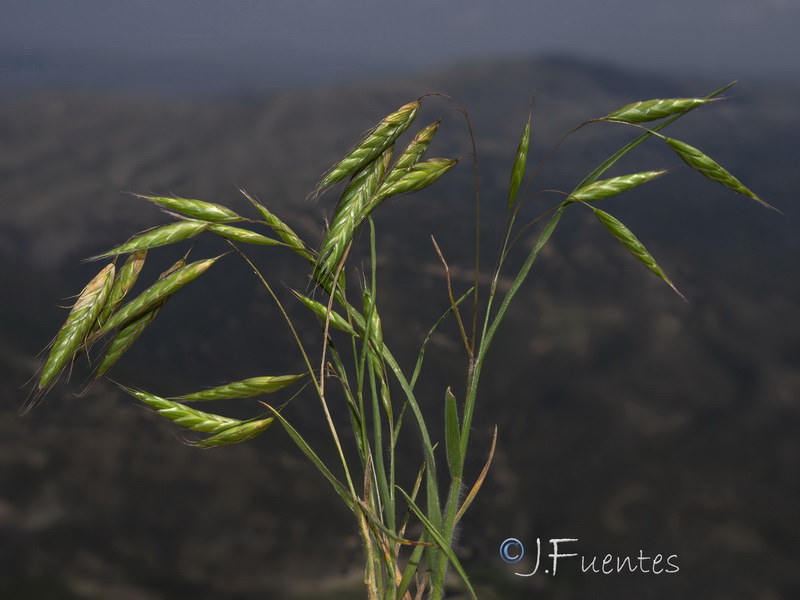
39;263;115;390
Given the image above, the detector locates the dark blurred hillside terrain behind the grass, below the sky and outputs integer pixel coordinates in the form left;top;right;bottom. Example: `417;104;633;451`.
0;58;800;600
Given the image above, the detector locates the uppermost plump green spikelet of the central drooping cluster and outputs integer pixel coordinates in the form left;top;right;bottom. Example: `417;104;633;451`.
317;100;421;191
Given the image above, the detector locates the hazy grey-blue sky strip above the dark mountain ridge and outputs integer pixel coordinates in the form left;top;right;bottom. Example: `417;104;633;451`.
0;0;800;93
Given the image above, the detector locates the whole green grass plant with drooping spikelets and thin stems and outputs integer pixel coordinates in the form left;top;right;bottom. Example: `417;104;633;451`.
34;84;772;600
